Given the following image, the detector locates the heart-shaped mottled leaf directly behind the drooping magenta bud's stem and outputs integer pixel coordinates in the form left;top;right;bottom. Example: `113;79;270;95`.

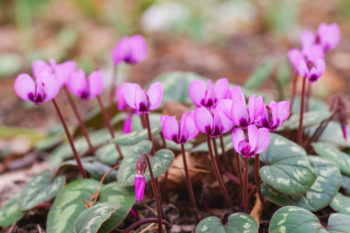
117;141;174;186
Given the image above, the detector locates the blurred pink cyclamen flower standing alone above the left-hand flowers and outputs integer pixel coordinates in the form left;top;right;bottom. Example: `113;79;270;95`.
112;35;147;65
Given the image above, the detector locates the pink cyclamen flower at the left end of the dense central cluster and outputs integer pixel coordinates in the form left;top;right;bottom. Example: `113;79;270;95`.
161;111;199;144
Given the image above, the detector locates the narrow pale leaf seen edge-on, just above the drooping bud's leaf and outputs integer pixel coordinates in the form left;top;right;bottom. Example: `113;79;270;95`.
112;127;162;145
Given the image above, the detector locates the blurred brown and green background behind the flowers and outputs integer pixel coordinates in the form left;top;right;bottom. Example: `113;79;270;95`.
0;0;350;164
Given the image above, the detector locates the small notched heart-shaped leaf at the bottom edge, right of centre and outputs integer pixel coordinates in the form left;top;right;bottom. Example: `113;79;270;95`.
196;213;258;233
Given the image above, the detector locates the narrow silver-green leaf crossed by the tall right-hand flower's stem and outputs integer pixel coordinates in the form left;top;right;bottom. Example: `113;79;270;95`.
277;110;331;131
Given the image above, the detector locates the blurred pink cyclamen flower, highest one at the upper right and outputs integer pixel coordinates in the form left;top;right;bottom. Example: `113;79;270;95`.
301;23;341;52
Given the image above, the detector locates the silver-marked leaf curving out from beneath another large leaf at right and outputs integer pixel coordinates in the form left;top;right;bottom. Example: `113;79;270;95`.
261;156;341;211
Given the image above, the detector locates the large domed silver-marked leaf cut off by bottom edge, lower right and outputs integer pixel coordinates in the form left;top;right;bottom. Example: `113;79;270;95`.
269;206;327;233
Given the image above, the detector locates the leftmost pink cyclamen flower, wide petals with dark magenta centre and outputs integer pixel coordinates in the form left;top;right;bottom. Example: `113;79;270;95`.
15;72;60;105
